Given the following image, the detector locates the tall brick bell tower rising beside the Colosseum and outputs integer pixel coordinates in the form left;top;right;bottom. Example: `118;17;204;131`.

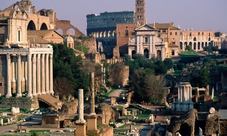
135;0;146;26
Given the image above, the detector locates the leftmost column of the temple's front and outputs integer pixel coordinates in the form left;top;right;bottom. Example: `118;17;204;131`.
6;54;12;98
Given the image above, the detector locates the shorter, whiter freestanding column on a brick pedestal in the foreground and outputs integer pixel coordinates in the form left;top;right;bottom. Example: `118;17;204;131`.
76;89;86;123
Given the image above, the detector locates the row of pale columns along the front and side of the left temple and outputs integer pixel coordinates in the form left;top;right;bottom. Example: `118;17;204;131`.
6;53;54;98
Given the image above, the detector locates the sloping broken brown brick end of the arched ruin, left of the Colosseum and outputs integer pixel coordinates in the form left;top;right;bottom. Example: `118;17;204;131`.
55;20;85;37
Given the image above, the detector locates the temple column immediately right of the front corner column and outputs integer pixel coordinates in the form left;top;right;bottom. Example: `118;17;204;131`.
32;54;37;96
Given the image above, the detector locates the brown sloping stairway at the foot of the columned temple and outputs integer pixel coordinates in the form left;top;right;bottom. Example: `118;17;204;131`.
38;94;63;109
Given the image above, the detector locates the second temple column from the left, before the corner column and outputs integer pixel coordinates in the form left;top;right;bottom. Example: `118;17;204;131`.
17;54;22;97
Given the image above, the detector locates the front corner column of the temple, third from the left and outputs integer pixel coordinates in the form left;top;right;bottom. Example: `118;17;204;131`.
27;54;32;97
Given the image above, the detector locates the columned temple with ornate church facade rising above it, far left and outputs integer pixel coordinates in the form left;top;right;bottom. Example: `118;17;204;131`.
0;0;54;98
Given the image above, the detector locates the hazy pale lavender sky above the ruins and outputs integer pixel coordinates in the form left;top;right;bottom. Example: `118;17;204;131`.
0;0;227;34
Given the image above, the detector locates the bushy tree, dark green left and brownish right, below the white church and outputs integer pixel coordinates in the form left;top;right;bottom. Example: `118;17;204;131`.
130;69;165;103
